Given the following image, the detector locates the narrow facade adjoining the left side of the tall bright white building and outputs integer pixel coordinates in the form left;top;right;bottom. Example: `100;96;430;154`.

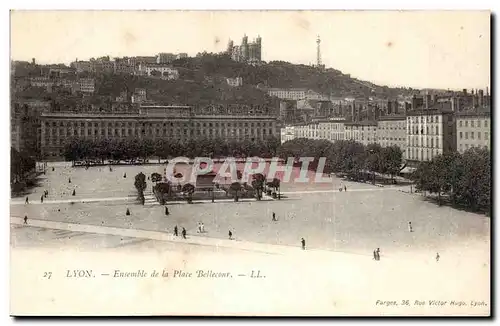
377;115;407;157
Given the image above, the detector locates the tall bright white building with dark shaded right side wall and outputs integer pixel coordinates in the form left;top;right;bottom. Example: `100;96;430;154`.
404;109;457;162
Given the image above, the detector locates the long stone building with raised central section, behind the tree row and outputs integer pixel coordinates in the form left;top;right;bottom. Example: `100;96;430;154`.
41;105;279;157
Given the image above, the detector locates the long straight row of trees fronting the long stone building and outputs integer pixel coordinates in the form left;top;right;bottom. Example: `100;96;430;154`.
63;137;280;162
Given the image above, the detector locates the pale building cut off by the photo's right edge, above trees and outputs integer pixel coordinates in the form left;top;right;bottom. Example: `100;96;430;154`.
457;112;491;153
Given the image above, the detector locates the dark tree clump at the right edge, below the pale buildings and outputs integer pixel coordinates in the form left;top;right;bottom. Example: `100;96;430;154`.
412;148;491;213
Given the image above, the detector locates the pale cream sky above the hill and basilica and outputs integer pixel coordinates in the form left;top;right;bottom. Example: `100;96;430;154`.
11;11;490;89
